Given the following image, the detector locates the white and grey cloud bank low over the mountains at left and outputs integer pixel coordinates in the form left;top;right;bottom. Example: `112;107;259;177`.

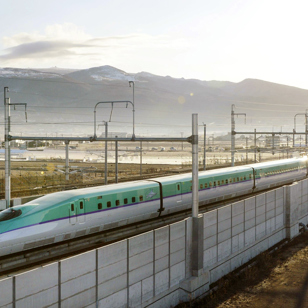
0;23;189;73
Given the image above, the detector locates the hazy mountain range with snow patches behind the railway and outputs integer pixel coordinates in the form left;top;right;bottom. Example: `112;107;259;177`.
0;65;308;134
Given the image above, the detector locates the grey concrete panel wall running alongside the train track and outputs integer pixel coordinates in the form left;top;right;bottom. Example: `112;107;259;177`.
0;180;308;308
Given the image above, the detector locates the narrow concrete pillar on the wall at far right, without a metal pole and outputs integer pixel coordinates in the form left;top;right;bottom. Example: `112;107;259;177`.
284;183;300;239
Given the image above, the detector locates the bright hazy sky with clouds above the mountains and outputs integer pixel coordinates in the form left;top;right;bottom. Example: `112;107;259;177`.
0;0;308;89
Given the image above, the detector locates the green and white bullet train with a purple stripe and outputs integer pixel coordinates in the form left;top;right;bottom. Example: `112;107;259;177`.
0;157;308;256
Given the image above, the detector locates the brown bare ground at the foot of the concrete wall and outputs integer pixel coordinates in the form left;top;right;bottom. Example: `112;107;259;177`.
177;232;308;308
